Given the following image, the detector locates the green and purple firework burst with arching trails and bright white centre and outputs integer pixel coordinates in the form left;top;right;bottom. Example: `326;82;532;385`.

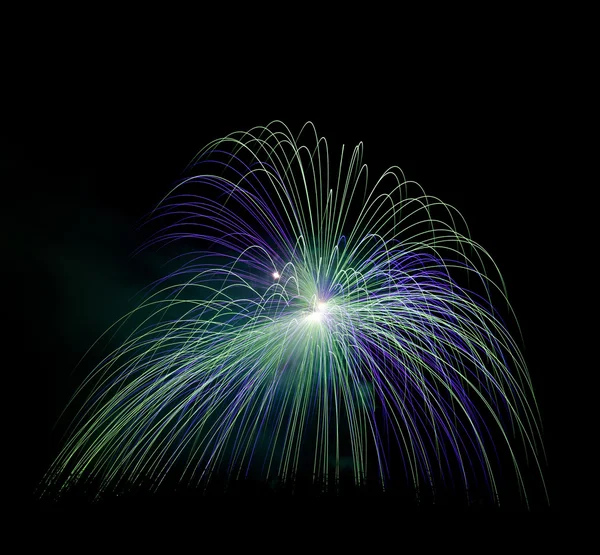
44;122;543;508
